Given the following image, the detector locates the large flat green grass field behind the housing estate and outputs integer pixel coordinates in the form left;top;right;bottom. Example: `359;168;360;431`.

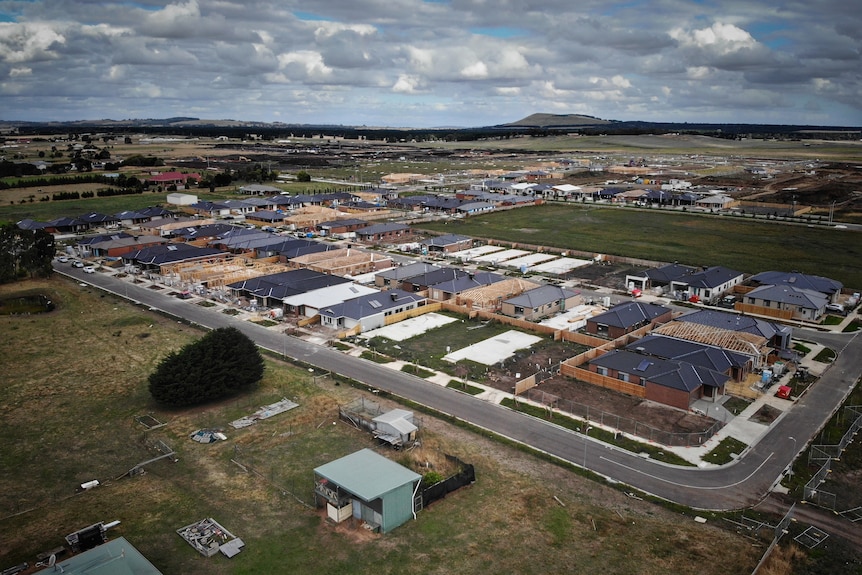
421;204;862;287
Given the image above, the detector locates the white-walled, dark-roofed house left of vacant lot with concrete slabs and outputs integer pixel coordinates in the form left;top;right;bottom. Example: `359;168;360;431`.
319;289;425;333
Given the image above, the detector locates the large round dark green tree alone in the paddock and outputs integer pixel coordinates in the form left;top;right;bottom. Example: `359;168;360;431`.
149;327;263;407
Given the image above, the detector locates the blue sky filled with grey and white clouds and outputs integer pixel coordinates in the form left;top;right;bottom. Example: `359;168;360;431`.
0;0;862;127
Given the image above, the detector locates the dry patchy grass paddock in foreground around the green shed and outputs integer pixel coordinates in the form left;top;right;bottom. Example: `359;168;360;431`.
0;279;763;575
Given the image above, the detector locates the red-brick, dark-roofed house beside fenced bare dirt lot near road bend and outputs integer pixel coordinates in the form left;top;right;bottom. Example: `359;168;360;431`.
588;349;728;411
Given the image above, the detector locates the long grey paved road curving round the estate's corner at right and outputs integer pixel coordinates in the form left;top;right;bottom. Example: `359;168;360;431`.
58;264;862;510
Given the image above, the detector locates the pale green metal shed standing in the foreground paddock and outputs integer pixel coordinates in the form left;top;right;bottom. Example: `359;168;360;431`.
314;449;422;533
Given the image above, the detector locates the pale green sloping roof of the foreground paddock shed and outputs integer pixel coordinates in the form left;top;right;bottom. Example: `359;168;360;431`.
314;449;422;501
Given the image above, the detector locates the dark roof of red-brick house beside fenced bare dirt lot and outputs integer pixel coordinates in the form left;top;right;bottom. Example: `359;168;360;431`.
590;349;727;393
